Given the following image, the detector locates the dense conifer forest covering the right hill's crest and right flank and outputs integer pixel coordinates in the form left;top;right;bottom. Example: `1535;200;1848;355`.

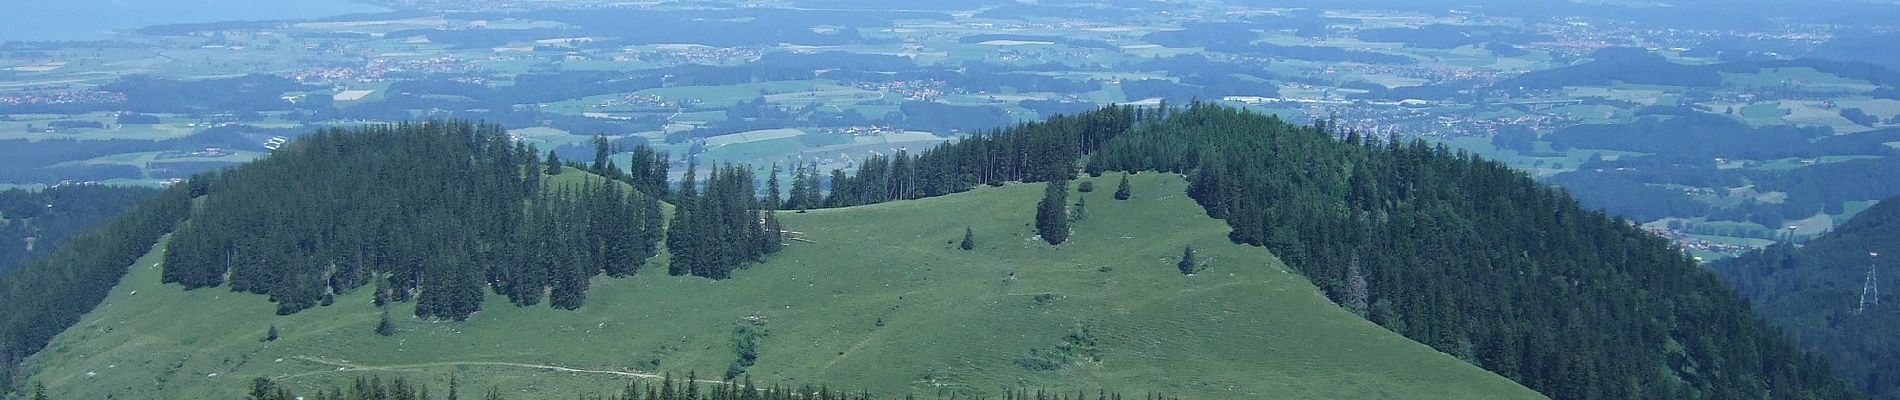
827;104;1856;398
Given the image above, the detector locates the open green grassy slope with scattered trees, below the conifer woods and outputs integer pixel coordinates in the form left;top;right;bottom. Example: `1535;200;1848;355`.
29;174;1541;398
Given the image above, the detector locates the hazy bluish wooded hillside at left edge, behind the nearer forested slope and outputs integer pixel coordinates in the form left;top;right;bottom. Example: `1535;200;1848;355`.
0;186;158;275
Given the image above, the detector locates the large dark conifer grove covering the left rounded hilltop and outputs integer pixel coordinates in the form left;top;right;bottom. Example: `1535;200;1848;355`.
163;121;663;320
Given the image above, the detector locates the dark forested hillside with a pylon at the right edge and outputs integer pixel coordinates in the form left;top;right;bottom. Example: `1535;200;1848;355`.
1710;197;1900;398
